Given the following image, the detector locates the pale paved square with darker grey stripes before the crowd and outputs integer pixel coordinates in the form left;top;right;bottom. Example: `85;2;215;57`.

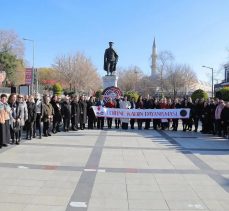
0;126;229;211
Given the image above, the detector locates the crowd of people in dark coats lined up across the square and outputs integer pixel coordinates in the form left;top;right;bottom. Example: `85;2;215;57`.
0;94;229;147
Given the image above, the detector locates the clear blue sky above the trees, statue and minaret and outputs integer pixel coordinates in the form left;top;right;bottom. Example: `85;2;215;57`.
0;0;229;81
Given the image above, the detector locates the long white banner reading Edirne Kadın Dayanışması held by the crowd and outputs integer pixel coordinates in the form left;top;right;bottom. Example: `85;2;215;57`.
92;106;190;119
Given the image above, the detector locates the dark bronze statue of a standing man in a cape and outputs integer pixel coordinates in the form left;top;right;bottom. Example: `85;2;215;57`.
103;42;118;75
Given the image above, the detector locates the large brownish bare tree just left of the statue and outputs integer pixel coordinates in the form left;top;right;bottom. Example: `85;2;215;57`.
53;53;101;93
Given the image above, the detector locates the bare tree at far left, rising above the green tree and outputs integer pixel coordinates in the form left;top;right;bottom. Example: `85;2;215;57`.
0;30;24;59
